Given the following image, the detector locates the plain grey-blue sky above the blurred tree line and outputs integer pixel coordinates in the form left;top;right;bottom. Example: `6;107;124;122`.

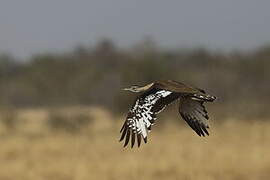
0;0;270;57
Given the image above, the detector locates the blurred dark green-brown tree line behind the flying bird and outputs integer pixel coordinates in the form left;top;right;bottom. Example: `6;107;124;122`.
0;40;270;117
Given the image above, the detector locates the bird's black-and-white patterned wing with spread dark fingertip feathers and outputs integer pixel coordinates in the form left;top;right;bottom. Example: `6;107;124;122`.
120;89;176;147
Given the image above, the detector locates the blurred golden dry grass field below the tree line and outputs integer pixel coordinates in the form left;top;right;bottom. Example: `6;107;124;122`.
0;108;270;180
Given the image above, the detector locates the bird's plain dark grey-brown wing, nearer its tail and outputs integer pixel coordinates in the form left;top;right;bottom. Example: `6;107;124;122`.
179;97;209;136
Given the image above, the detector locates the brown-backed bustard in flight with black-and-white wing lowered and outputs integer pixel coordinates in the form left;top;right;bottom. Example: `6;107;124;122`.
120;80;216;148
